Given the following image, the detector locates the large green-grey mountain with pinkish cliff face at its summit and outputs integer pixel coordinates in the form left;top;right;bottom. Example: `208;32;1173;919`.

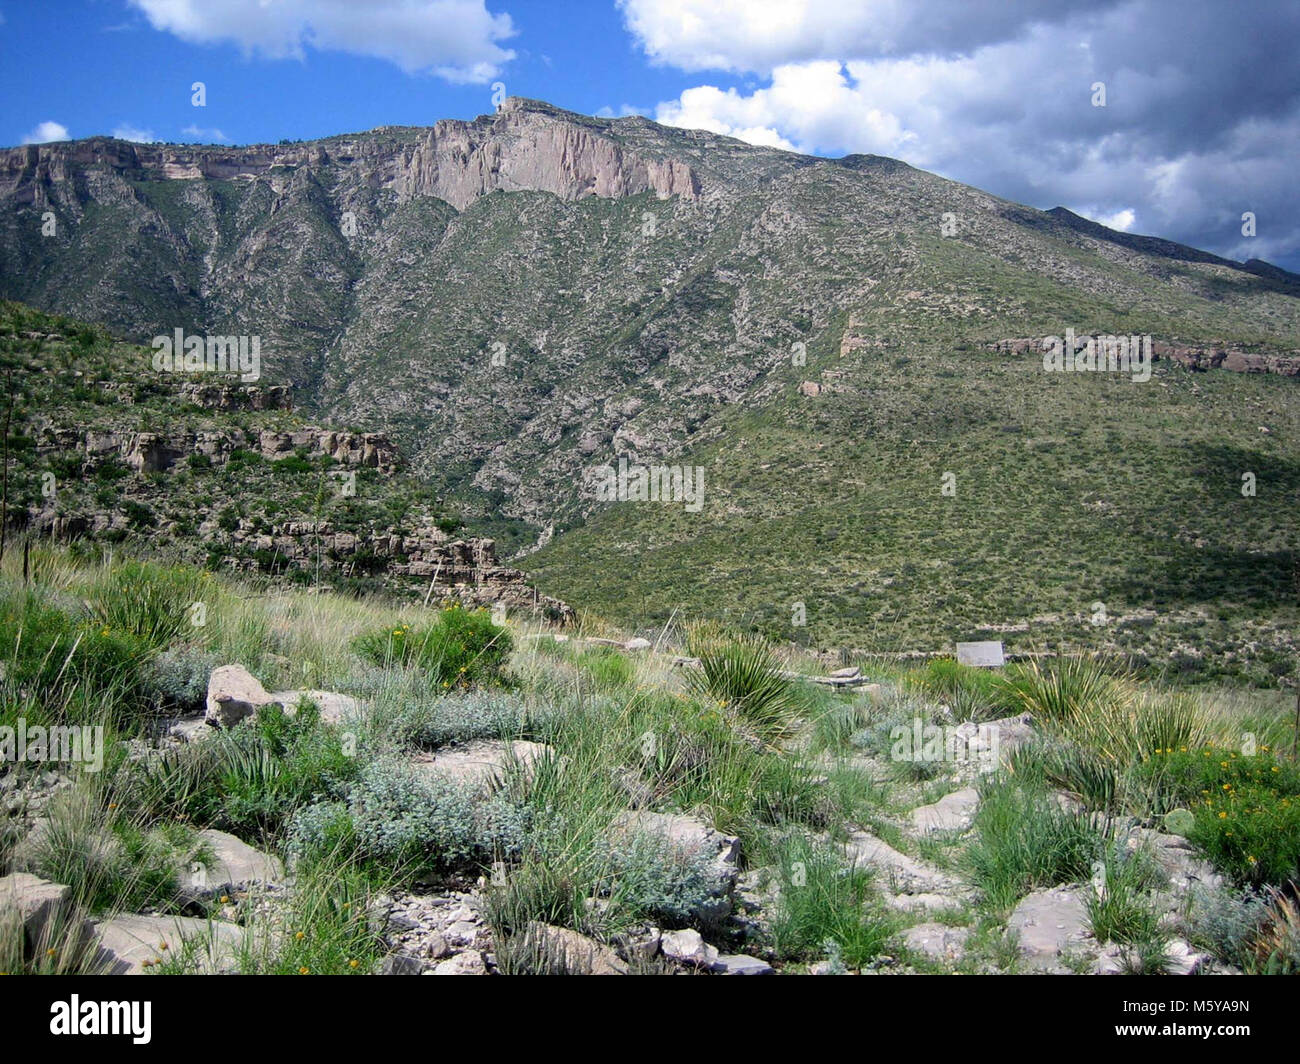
0;99;1300;683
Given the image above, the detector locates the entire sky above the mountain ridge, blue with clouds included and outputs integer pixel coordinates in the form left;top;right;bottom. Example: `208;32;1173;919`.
0;0;1300;271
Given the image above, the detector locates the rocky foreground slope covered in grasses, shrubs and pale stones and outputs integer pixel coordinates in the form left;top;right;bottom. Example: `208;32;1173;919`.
0;548;1300;974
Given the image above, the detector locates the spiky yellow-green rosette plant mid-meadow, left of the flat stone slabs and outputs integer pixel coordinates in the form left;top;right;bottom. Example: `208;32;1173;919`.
686;636;798;744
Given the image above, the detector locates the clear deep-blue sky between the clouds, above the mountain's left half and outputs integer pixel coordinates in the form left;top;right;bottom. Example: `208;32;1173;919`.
0;0;696;144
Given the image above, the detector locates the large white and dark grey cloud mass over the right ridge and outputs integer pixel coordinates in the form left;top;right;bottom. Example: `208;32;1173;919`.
634;0;1300;269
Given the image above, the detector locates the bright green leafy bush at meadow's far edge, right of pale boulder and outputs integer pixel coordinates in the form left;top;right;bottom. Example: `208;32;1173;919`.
354;605;512;688
